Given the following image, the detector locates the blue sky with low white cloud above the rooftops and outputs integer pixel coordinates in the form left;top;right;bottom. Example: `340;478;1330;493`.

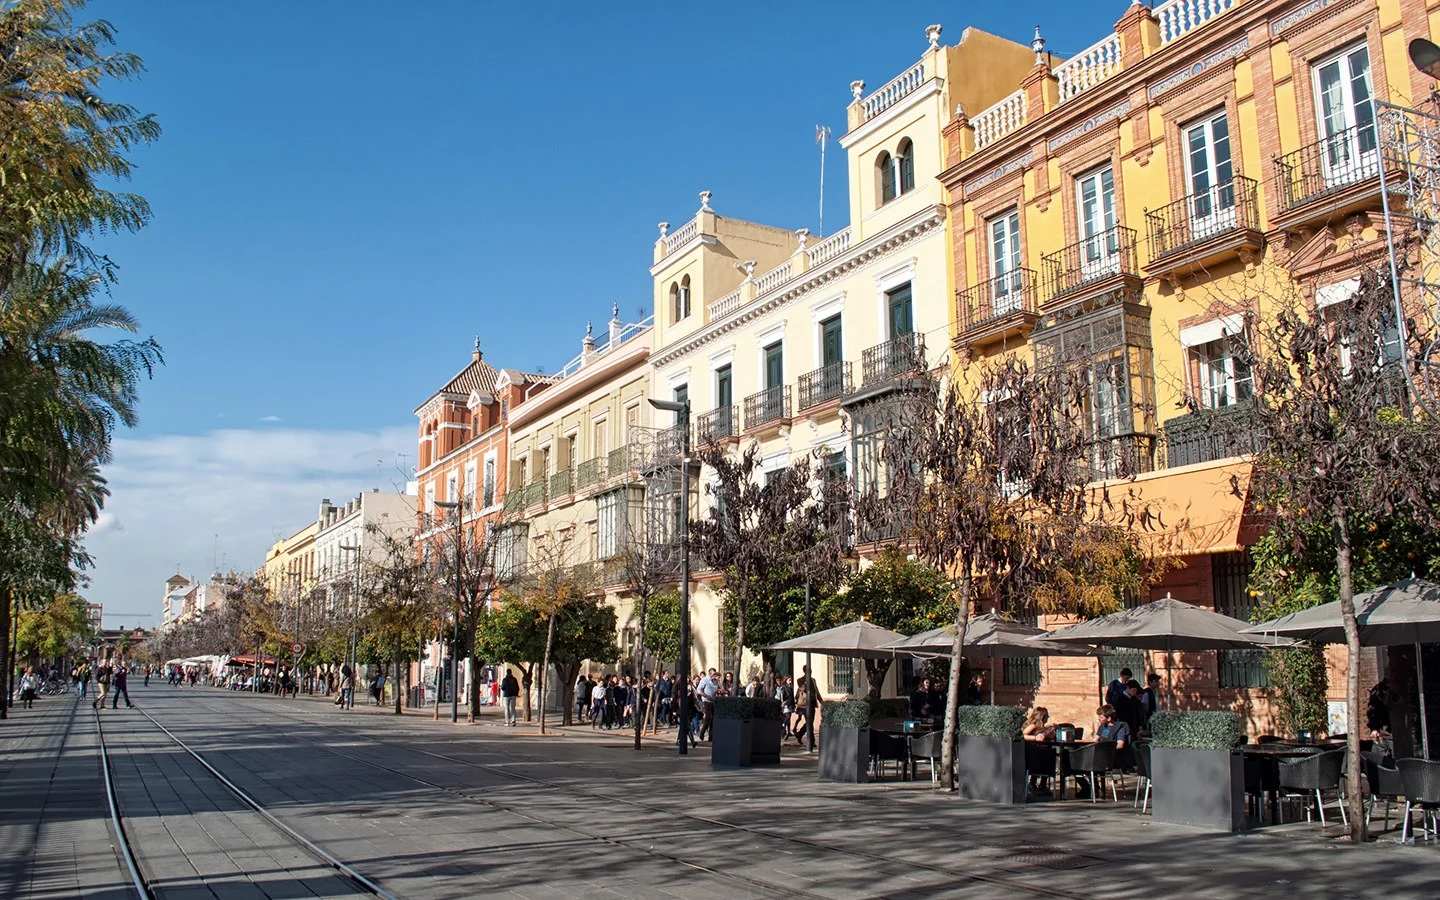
89;0;1100;625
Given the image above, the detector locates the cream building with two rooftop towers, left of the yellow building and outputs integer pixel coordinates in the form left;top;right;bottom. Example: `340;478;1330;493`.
651;26;1034;696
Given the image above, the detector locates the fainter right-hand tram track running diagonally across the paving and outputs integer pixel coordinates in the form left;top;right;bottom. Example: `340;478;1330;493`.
177;694;1074;900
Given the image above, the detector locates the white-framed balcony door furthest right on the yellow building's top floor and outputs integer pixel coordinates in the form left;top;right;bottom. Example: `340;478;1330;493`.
1315;46;1377;187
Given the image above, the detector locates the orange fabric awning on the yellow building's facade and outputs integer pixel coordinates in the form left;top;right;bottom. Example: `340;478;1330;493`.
1109;461;1260;556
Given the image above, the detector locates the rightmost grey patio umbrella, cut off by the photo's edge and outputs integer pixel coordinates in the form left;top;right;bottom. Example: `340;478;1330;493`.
1246;577;1440;757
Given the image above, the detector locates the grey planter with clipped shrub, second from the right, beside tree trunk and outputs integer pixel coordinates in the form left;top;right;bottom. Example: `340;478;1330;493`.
955;706;1025;804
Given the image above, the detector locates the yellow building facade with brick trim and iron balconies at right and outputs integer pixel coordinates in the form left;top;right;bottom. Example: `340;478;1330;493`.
940;0;1436;727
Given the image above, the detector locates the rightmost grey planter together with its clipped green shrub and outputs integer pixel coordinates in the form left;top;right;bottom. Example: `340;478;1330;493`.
1151;711;1246;831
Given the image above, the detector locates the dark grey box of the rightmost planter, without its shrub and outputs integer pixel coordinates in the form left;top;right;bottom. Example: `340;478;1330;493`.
1151;747;1246;831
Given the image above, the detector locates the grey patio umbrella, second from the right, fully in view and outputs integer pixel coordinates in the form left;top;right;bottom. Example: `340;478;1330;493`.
1031;593;1290;704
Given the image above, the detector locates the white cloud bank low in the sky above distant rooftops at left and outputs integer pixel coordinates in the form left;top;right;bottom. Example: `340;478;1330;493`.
85;428;415;626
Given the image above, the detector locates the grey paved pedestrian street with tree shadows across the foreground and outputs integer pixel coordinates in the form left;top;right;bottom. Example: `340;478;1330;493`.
0;684;1440;900
